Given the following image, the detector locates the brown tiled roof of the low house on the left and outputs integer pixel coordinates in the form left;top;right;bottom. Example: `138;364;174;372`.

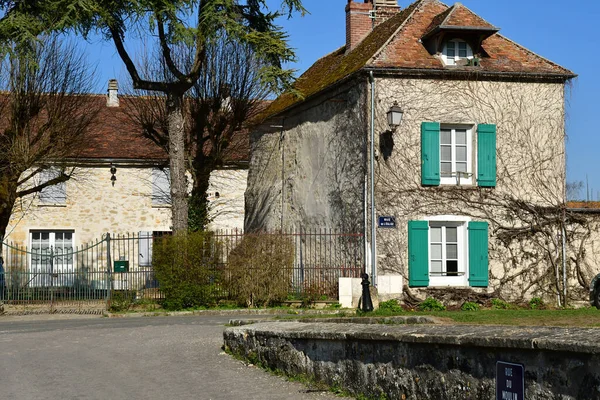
76;95;250;163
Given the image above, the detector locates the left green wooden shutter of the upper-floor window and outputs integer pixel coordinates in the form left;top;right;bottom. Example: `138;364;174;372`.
421;122;440;186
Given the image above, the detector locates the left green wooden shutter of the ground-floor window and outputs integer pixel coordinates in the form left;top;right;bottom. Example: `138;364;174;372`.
408;221;429;287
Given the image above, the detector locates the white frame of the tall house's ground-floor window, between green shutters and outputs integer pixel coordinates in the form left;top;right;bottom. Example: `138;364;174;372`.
425;215;471;287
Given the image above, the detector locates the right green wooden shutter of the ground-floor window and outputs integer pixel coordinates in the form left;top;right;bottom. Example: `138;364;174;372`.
469;222;489;287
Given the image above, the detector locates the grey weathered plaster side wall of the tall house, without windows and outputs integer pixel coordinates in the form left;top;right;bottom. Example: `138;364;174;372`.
245;80;367;232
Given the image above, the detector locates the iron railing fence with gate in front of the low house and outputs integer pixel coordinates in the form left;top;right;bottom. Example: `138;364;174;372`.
0;229;364;312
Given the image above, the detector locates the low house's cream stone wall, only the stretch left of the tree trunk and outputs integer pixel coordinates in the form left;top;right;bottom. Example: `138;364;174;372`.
7;167;171;245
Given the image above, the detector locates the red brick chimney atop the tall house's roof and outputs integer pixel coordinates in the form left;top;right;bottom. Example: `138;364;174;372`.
346;0;400;53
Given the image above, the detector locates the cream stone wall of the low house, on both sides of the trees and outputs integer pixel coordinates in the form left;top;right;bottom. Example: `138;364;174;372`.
6;166;247;246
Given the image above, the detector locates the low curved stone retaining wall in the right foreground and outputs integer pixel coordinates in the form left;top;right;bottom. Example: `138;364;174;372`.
223;322;600;400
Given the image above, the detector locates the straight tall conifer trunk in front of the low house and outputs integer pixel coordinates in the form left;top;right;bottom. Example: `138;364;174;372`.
167;93;188;233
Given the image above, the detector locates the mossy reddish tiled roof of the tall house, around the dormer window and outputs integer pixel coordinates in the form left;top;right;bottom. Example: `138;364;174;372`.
261;0;575;118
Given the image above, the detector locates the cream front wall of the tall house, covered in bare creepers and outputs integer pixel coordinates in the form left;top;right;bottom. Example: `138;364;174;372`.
375;78;565;299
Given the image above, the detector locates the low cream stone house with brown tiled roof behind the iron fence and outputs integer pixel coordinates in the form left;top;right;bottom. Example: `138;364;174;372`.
5;81;248;256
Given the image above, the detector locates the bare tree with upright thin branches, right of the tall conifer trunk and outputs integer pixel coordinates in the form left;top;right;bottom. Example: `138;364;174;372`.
124;37;269;230
